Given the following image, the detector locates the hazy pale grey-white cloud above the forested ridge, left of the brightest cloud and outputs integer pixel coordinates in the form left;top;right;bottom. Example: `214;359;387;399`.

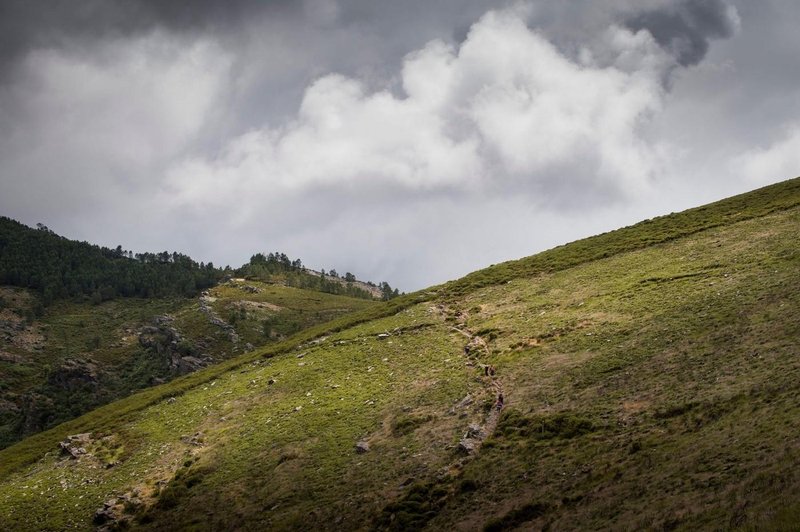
0;32;230;210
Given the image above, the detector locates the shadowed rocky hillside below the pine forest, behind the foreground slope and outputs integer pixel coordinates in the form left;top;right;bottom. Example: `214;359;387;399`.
0;281;374;448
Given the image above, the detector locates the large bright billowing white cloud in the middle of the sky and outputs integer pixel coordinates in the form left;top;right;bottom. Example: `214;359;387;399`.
164;10;672;213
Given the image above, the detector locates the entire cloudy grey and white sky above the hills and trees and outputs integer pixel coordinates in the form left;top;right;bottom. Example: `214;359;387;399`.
0;0;800;291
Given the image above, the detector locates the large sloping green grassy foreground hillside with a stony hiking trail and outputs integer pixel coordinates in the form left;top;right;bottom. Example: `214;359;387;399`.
0;179;800;530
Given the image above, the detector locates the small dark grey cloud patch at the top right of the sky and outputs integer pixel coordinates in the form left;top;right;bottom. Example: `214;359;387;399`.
624;0;738;66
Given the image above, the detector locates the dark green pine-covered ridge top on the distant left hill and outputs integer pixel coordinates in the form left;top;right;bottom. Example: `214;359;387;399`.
0;217;398;306
